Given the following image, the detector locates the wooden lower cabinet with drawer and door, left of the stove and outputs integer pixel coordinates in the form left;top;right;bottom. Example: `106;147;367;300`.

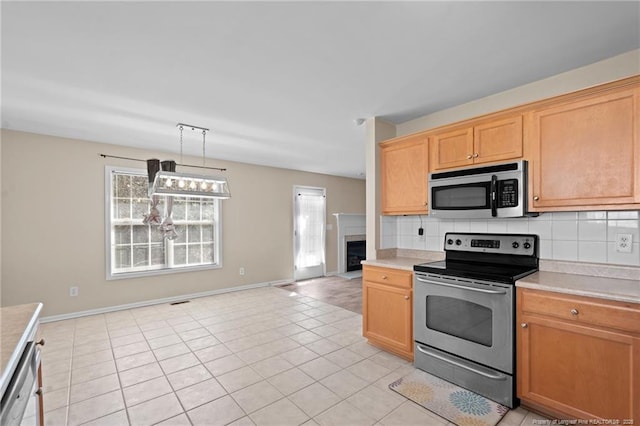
362;265;413;361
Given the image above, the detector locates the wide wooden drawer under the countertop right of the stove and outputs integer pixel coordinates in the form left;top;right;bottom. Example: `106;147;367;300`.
520;289;640;333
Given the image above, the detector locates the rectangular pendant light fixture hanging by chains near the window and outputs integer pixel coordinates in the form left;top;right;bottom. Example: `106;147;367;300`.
147;123;231;199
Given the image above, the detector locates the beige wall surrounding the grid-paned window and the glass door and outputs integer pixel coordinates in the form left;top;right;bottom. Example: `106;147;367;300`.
1;130;365;316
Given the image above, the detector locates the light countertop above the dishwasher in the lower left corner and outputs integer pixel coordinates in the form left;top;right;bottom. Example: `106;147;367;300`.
0;303;42;395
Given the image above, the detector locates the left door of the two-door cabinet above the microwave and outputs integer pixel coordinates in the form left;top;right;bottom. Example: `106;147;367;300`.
431;127;474;170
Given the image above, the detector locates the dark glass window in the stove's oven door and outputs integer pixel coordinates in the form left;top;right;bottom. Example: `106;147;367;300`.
426;296;493;347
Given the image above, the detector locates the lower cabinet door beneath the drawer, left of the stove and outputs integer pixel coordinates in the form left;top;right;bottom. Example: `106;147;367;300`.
362;281;413;359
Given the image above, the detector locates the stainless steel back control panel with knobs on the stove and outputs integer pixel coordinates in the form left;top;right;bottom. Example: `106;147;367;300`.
444;232;538;256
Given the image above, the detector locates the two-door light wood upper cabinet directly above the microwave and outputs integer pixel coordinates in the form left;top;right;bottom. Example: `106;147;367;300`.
431;115;522;170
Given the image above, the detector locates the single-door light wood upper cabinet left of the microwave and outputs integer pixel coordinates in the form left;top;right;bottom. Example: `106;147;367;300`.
380;135;429;215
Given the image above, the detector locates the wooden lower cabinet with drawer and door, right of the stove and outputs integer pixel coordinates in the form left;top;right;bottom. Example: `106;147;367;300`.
517;288;640;424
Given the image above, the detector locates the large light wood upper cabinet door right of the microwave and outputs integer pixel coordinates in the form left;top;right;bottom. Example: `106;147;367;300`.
529;89;640;211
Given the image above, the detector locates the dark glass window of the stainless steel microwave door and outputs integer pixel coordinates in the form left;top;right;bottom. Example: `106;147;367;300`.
431;182;491;210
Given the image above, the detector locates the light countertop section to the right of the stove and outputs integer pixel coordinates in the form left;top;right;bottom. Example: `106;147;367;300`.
516;271;640;303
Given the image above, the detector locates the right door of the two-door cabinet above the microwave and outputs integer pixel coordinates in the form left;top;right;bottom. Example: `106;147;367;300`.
473;115;522;163
